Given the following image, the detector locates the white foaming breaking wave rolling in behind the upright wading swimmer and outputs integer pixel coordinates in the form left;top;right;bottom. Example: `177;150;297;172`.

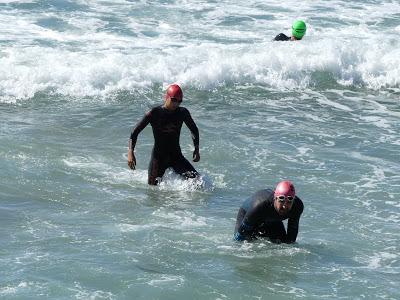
0;38;400;102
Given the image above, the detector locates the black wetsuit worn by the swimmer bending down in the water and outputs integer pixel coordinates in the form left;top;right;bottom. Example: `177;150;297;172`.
234;189;304;243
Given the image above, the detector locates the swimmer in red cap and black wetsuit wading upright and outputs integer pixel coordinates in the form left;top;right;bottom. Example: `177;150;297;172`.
128;84;200;185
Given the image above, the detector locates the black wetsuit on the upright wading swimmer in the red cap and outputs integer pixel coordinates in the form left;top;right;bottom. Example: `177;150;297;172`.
131;105;199;184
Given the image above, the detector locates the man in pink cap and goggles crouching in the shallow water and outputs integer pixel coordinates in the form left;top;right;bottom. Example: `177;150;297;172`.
234;181;304;243
